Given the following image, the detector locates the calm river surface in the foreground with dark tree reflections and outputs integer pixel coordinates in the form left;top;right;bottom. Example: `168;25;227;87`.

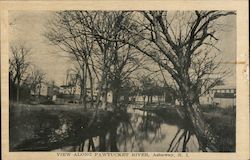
70;108;198;152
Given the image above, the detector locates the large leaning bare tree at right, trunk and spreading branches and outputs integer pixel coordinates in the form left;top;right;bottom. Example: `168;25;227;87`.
124;11;235;151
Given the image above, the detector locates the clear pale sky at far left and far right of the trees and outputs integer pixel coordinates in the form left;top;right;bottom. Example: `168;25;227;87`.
9;11;236;85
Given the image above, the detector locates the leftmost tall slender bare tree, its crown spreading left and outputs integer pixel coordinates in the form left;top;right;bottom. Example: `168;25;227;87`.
45;11;94;107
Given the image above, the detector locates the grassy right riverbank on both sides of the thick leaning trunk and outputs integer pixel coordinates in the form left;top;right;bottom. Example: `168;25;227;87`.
137;105;236;152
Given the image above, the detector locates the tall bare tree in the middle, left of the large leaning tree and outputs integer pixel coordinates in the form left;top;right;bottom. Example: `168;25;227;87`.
75;11;143;108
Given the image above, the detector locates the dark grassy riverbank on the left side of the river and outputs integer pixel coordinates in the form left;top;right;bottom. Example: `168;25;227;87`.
9;104;114;151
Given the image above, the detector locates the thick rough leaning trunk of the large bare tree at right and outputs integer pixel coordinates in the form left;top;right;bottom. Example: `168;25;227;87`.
175;68;217;152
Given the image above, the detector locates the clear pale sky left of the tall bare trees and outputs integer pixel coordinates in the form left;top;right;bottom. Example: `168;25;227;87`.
9;11;70;85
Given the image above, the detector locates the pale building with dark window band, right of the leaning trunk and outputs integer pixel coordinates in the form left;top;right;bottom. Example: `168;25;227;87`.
200;85;236;108
